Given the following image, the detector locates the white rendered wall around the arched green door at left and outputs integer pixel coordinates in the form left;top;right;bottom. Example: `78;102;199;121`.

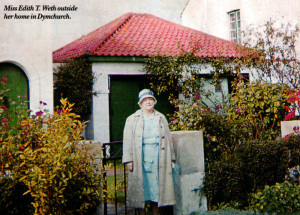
0;20;53;111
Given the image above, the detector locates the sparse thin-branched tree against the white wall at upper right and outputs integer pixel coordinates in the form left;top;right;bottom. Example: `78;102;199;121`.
241;19;300;89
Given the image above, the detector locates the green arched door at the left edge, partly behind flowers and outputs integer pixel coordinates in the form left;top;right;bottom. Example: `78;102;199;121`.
0;63;29;120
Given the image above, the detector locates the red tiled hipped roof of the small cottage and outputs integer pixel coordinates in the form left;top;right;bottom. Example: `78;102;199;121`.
53;13;246;63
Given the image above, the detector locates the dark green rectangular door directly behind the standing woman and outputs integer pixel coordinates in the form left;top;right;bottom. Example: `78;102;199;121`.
109;75;173;142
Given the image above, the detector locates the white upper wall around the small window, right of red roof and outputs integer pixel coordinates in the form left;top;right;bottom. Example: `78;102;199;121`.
182;0;300;53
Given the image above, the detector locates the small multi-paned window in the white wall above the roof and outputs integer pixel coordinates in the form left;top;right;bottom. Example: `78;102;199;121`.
228;10;241;43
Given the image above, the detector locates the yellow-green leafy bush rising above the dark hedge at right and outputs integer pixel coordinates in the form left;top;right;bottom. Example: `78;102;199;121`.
228;82;288;140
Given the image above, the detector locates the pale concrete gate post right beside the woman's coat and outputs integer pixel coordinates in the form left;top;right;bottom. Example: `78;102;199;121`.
171;131;207;215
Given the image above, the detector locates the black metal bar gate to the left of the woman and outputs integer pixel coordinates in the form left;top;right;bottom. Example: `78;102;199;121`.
102;141;127;215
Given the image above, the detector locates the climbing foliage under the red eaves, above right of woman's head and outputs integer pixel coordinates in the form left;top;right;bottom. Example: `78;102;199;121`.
145;42;241;105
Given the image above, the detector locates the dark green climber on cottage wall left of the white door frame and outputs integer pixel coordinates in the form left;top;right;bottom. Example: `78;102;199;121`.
54;56;95;117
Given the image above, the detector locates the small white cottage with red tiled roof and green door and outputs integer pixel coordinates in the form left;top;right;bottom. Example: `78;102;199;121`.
53;13;248;142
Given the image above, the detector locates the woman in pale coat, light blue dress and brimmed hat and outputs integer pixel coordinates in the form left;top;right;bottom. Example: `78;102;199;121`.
122;89;175;214
